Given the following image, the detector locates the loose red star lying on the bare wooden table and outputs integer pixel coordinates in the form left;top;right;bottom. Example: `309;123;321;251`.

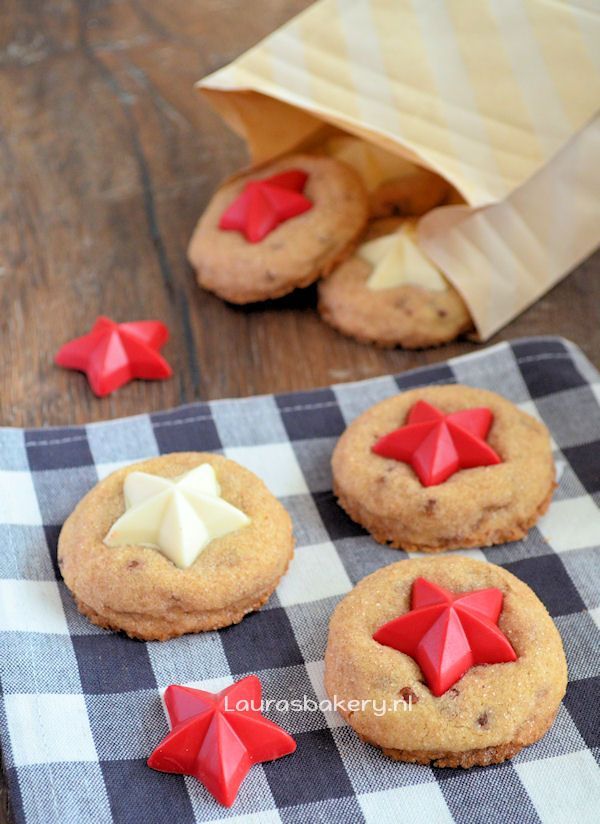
54;317;173;397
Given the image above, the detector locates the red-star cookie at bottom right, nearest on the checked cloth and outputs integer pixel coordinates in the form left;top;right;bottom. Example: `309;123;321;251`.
325;557;567;767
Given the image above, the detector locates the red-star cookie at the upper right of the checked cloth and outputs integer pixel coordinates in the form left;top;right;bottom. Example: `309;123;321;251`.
332;385;555;552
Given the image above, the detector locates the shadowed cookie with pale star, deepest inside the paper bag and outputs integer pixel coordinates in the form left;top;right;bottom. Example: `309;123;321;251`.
325;135;451;217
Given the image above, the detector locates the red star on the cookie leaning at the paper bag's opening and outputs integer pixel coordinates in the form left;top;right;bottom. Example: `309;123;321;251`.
219;169;312;243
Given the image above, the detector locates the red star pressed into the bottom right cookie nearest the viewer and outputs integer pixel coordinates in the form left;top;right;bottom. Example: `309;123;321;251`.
373;578;517;695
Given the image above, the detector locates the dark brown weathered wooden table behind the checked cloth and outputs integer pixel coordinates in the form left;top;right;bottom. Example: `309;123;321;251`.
0;0;600;824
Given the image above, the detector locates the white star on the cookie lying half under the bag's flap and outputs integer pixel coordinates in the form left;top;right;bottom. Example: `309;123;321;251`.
358;221;448;292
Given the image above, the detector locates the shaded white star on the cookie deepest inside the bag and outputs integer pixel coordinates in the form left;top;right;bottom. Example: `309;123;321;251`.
327;135;419;192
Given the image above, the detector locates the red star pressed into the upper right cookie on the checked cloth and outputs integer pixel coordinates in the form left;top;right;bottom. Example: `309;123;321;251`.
373;401;502;486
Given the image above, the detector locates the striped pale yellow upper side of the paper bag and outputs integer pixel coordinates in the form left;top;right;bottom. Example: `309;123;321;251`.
199;0;600;206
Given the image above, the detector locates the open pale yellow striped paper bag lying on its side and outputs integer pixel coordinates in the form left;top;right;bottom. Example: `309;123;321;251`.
198;0;600;340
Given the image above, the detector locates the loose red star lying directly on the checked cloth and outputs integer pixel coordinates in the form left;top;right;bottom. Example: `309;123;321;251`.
148;675;296;807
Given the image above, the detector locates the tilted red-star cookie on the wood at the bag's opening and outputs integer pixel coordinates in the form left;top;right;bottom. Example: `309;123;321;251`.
188;154;368;303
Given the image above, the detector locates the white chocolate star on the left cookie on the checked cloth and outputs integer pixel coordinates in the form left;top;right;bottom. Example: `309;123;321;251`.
104;464;250;569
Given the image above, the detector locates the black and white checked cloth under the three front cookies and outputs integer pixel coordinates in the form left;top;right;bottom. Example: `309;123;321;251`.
0;338;600;824
